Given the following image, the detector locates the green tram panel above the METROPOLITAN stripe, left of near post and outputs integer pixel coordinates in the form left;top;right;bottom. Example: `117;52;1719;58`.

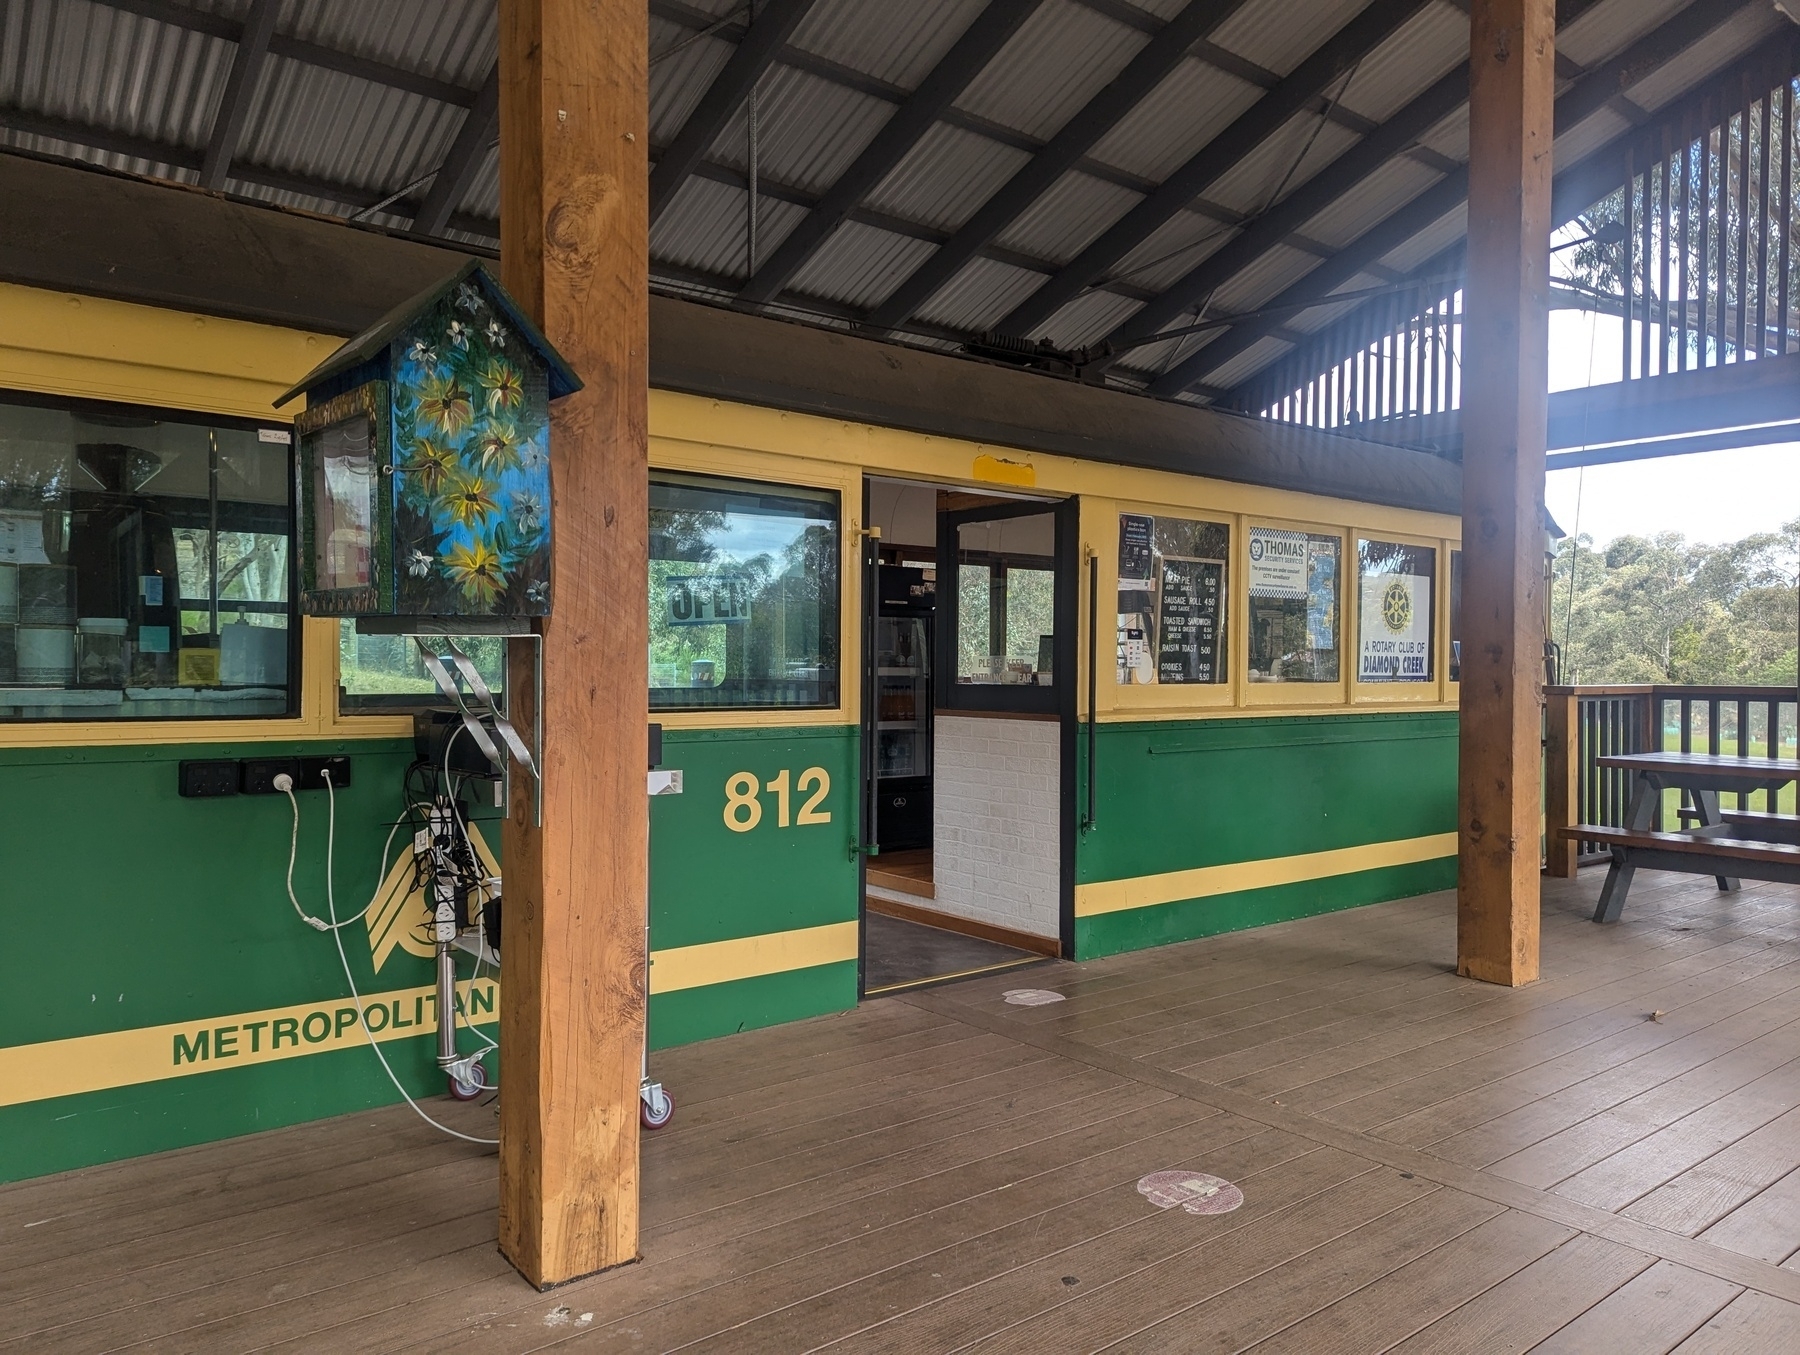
0;740;432;1044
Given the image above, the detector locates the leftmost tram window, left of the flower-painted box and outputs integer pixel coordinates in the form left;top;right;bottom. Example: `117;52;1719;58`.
0;394;297;720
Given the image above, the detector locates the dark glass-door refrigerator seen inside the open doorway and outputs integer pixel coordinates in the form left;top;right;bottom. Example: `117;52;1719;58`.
875;565;936;851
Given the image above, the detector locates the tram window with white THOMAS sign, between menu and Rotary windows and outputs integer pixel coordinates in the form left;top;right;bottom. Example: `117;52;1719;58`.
1249;527;1343;682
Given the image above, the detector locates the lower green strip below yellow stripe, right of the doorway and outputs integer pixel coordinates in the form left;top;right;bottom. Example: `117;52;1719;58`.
1075;857;1456;959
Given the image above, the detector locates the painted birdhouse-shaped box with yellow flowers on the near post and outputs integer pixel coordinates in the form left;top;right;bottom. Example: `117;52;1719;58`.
275;259;581;619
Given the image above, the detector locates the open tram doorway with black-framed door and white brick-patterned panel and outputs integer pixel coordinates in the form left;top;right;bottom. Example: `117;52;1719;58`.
862;477;1073;993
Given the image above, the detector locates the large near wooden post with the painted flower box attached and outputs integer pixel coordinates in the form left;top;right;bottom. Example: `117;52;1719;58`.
500;0;650;1287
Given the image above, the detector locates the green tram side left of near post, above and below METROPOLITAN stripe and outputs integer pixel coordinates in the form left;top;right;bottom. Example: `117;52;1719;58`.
0;740;499;1177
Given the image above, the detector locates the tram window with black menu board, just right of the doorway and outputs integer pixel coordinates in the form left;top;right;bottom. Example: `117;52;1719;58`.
1118;513;1231;686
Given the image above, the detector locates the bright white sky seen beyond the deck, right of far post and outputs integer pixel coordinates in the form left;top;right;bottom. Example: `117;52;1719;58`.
1544;287;1800;545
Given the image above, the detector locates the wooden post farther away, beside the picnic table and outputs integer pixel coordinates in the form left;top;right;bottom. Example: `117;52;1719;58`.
1456;0;1555;984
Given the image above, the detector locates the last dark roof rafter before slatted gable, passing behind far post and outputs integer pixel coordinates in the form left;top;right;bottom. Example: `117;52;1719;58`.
1148;0;1750;398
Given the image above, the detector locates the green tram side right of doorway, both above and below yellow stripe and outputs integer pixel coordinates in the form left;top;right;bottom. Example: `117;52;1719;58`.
1076;711;1456;959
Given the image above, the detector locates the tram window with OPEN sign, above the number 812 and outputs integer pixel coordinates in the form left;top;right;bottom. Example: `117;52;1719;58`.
650;473;839;711
